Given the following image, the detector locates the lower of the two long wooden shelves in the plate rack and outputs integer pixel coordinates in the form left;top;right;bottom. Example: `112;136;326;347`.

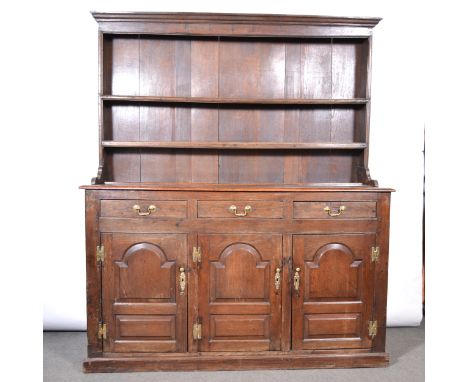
102;141;367;150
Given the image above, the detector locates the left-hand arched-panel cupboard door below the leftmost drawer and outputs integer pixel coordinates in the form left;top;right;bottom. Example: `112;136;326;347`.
101;234;188;352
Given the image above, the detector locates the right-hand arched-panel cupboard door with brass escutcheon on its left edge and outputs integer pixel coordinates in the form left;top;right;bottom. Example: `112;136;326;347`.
292;234;375;349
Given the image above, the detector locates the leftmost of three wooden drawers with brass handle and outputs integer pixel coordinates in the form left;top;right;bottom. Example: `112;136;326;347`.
101;200;187;219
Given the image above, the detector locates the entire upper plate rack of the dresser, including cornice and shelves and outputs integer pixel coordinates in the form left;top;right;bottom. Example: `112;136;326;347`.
93;13;379;185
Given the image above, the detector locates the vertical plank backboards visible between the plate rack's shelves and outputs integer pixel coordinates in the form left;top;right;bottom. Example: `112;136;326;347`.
102;35;370;184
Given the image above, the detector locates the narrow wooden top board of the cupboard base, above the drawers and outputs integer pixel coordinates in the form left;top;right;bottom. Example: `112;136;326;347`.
80;183;395;192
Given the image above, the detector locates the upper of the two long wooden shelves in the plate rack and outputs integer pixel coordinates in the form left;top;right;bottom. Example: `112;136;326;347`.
101;95;369;106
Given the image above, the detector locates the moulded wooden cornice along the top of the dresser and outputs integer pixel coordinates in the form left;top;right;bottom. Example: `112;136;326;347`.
92;12;381;37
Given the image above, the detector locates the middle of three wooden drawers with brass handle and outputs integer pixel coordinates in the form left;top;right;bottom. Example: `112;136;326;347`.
198;200;284;219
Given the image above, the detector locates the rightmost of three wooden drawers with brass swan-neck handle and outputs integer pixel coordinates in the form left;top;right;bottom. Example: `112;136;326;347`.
293;201;377;219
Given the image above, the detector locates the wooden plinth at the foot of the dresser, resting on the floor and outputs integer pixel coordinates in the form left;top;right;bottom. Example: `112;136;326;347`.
83;352;389;373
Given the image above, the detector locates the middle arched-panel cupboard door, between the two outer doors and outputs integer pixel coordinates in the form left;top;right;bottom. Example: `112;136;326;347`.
199;234;282;351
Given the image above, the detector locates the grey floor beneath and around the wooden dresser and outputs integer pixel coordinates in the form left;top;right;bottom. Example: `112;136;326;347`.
44;326;424;382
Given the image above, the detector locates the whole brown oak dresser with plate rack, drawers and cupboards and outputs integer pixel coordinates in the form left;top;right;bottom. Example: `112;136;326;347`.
82;13;393;372
